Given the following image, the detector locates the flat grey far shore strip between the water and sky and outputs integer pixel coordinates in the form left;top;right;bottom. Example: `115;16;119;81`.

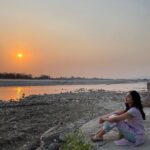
0;79;149;87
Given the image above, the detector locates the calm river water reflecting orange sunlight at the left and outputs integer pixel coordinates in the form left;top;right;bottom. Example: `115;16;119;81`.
0;82;147;100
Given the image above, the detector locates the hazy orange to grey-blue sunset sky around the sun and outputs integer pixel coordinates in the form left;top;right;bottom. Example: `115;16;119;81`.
0;0;150;78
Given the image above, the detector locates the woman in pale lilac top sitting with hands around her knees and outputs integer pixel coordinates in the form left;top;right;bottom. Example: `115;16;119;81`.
91;91;145;146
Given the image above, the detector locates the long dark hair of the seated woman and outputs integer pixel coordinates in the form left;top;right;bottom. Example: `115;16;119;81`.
125;91;146;120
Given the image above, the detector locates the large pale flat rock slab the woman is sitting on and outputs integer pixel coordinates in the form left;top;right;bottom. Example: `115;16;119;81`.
81;108;150;150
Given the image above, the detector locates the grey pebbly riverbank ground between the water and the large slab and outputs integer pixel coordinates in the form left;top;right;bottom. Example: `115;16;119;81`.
0;89;148;150
